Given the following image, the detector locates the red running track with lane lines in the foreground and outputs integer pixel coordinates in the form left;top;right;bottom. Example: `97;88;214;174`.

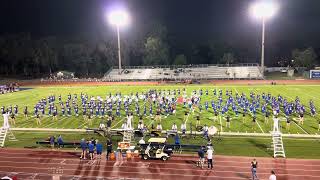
0;149;320;180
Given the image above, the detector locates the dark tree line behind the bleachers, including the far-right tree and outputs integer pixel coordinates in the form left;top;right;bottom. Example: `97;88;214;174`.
0;24;317;77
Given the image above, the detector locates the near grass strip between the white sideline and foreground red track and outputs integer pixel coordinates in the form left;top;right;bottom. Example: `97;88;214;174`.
6;132;320;159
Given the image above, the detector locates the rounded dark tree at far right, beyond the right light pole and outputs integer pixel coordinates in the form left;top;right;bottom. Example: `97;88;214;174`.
292;47;317;69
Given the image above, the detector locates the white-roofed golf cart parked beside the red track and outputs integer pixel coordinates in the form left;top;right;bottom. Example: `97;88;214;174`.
141;138;172;161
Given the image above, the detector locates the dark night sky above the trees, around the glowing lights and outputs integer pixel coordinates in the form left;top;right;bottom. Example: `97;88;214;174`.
0;0;320;63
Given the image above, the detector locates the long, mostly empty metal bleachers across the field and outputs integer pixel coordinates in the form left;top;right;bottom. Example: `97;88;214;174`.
103;64;263;81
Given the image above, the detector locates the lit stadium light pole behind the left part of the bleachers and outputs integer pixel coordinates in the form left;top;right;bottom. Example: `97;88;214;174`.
108;10;129;74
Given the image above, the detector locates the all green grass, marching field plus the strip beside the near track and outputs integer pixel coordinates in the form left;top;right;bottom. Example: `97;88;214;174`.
0;85;320;158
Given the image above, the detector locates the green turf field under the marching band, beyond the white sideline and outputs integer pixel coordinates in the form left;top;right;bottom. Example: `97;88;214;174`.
0;85;320;134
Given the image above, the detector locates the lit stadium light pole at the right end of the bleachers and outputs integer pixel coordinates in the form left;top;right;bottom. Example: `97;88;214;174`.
250;0;278;76
